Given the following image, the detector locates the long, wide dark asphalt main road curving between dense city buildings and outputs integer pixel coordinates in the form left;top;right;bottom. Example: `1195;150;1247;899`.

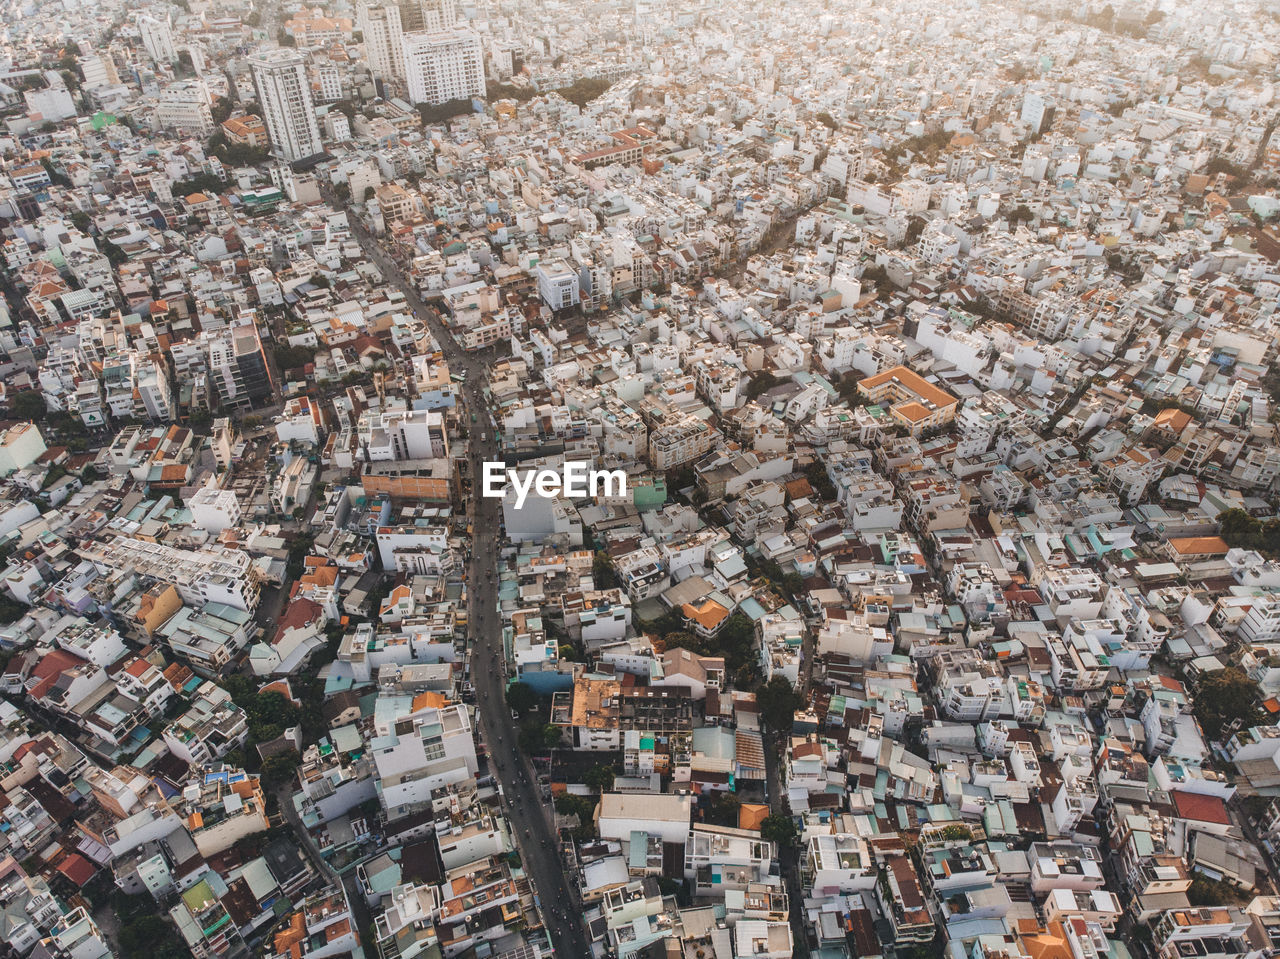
321;178;591;956
